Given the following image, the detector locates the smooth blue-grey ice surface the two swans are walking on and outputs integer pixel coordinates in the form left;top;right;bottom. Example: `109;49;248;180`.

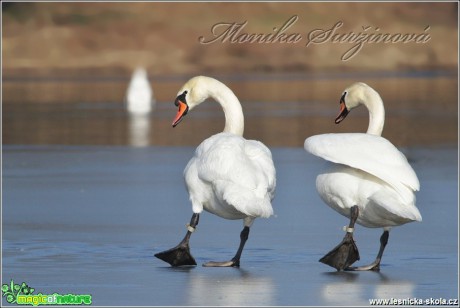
2;145;459;306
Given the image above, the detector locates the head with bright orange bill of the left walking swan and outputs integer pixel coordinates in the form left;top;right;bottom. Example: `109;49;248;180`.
172;76;211;127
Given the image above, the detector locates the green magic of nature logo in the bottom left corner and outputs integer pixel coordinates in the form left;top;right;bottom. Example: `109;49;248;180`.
2;280;92;306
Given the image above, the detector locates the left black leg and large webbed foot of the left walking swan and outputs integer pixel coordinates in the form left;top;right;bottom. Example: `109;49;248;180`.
155;213;200;266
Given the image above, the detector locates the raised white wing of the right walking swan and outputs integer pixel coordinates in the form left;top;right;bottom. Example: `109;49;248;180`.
304;133;420;201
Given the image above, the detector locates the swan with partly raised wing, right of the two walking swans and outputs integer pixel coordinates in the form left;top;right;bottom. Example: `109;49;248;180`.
304;82;422;271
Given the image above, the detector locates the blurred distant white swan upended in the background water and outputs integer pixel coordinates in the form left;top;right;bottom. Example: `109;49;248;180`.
126;68;155;115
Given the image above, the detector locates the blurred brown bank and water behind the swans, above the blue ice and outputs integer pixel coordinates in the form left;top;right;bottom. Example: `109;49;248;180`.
2;2;458;147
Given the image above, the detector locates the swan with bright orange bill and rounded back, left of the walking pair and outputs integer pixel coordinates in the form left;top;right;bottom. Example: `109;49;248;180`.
155;76;276;267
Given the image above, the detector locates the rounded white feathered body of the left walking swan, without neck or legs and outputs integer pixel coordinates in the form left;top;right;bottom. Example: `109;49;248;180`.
184;133;276;219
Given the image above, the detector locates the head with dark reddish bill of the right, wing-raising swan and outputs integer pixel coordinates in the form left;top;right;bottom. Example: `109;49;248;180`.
335;82;375;124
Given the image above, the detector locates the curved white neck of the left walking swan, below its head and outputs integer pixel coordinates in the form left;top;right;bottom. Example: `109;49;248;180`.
208;79;244;136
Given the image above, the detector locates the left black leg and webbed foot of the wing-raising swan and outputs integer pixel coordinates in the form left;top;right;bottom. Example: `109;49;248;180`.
319;205;359;271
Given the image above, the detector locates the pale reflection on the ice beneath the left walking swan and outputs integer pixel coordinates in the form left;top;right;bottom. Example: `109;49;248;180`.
187;268;276;306
